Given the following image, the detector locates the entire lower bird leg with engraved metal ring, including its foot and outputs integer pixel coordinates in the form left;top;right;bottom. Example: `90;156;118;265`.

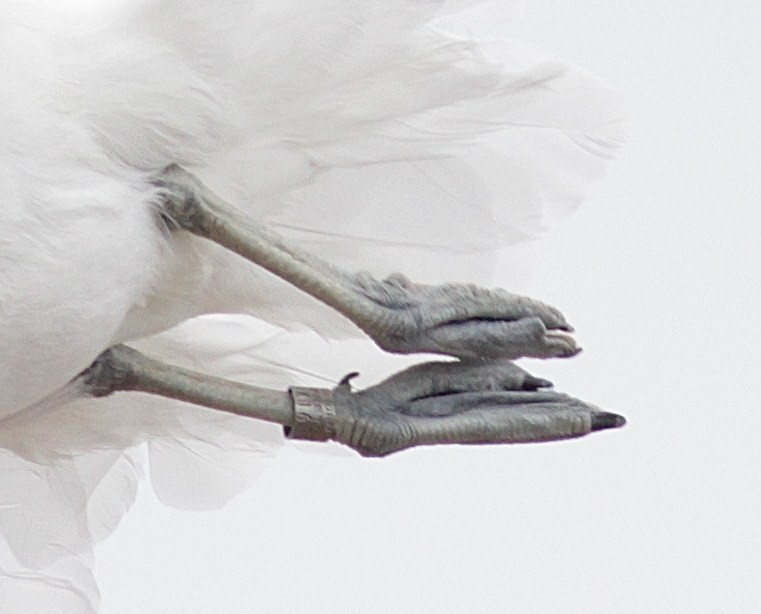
77;346;625;456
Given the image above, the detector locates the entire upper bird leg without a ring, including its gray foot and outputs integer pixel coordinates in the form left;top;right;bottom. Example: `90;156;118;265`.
153;165;579;359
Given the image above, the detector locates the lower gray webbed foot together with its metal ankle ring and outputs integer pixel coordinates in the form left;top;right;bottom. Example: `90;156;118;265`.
287;360;625;456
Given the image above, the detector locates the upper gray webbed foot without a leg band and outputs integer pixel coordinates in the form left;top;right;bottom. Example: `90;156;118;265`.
353;274;581;359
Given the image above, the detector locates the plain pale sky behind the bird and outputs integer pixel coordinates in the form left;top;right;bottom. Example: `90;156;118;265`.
96;0;761;614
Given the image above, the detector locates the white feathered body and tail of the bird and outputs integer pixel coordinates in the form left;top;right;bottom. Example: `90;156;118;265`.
0;0;619;614
